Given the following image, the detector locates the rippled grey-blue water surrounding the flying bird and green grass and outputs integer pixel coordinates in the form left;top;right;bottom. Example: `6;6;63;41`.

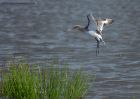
0;0;140;99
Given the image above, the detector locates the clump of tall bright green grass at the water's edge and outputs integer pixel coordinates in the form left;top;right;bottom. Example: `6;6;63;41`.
1;63;91;99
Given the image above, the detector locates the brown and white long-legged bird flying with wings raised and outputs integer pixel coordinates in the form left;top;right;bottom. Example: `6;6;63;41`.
68;13;113;56
